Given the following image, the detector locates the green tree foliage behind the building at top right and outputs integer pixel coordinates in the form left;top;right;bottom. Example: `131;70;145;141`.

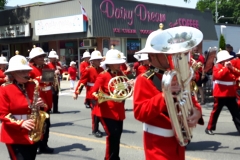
196;0;240;24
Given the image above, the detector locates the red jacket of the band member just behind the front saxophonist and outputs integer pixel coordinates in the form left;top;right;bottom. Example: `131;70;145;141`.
29;63;52;111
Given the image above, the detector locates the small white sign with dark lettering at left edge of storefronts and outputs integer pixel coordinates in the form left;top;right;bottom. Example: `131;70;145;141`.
0;24;30;39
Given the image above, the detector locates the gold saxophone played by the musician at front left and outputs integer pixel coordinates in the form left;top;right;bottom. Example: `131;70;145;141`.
28;79;49;142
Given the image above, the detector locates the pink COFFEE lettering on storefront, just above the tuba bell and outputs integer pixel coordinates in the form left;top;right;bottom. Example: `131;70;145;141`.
169;18;199;28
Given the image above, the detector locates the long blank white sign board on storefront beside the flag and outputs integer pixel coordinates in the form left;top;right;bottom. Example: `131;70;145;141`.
35;14;86;36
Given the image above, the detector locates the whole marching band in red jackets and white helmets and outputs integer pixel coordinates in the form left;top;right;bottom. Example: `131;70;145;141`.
0;27;240;160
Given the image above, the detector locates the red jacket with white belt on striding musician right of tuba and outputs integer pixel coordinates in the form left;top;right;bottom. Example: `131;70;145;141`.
213;63;240;97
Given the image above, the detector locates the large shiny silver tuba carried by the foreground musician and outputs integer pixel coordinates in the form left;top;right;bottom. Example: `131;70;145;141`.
151;26;203;146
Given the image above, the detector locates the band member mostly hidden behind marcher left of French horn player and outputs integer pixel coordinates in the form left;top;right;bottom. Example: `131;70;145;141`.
79;51;91;108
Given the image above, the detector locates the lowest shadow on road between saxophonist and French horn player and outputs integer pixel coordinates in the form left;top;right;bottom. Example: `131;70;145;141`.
54;143;92;154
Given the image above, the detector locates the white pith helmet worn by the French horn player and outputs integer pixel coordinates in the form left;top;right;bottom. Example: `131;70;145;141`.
104;46;126;64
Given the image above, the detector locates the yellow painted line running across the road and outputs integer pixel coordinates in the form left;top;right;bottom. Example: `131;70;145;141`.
50;132;204;160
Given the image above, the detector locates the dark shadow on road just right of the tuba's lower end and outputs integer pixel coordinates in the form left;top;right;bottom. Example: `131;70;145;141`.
186;141;229;151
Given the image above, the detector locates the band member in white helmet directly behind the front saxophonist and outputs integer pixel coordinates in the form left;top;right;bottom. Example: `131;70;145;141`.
29;46;54;154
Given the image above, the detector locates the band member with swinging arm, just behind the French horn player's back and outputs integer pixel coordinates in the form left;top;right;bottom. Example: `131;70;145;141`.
73;50;103;138
